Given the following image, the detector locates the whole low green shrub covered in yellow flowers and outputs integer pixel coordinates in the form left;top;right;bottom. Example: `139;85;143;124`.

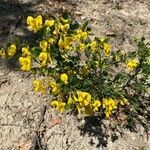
0;14;150;118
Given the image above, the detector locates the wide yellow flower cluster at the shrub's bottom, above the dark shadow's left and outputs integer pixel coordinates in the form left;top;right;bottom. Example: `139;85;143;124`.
51;91;101;115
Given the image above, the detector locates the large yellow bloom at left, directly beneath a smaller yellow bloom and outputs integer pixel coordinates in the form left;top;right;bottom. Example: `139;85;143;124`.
19;57;31;71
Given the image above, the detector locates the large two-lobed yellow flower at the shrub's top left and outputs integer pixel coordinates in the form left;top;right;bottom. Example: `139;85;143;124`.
27;15;42;33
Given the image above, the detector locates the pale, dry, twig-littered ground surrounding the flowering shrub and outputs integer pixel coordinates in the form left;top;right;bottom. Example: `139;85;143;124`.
0;0;150;150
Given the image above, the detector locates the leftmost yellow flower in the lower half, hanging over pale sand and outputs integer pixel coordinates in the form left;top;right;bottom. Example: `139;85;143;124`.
33;80;45;94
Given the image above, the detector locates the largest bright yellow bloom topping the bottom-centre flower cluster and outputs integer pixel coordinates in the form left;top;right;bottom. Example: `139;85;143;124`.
76;91;91;106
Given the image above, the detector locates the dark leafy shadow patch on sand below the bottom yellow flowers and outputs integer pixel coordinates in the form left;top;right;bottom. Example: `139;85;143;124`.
78;116;122;148
